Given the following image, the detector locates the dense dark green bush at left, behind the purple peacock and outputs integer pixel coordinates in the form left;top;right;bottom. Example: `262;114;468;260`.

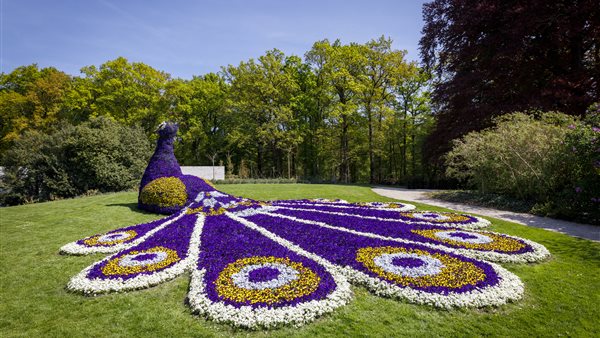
0;118;152;205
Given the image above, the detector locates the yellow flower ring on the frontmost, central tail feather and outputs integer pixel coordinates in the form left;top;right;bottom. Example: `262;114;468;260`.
214;256;321;305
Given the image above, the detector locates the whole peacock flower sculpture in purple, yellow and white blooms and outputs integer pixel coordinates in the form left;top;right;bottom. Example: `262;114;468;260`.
61;123;549;328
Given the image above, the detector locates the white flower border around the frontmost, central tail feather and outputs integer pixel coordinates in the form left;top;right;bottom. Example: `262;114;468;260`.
188;213;352;329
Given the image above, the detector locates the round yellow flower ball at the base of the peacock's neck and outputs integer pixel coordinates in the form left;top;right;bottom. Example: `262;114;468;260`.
140;177;187;208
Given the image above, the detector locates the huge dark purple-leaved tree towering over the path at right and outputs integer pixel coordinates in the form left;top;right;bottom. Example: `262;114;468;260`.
420;0;600;162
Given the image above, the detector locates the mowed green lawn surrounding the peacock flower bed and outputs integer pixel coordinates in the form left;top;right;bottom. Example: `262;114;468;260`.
0;184;600;337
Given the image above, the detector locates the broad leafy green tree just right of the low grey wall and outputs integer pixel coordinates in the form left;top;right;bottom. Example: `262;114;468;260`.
223;49;299;176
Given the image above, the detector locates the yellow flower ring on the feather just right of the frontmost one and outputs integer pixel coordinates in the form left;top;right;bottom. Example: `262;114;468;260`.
356;246;485;289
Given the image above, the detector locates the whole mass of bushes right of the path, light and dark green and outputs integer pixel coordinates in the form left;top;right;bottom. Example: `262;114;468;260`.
446;112;600;223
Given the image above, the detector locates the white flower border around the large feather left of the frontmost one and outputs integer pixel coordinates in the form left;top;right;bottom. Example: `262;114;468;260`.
67;214;205;295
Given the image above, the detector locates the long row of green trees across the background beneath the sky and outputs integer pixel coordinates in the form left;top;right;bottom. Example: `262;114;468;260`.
0;37;433;183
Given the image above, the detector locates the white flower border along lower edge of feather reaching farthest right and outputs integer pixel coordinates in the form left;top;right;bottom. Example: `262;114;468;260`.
253;210;550;263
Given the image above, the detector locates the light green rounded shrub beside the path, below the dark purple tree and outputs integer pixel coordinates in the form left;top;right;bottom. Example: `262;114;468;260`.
446;113;575;199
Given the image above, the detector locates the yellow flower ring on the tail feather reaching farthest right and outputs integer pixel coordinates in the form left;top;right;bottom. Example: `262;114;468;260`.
411;229;526;252
